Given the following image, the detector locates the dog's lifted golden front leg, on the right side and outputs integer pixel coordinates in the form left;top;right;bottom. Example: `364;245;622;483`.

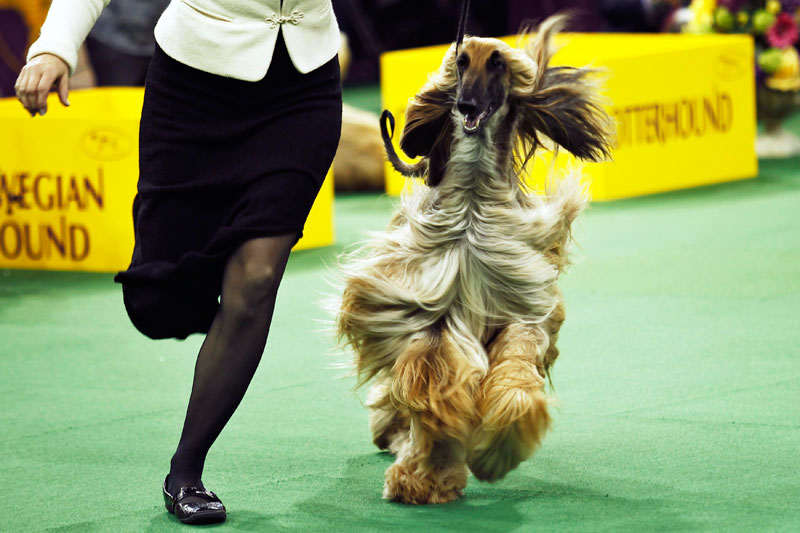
467;324;550;482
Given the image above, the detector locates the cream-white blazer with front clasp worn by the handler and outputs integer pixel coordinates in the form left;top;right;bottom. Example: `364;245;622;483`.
28;0;339;81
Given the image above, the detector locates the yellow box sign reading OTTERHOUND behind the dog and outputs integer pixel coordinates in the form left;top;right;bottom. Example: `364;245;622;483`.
381;34;758;200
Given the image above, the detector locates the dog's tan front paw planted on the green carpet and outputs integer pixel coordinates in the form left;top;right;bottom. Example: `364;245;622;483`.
383;463;467;505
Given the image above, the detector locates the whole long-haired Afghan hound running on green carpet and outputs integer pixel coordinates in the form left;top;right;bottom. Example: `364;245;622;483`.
337;17;611;504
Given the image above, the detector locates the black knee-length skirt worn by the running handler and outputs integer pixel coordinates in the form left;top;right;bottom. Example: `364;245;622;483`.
114;38;342;339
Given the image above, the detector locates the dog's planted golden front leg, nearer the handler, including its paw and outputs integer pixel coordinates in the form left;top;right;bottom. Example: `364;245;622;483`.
383;331;482;504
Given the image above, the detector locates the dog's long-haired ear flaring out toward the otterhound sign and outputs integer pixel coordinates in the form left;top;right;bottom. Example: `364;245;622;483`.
511;15;614;176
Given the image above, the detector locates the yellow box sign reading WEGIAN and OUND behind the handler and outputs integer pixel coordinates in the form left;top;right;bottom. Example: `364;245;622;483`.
0;88;333;272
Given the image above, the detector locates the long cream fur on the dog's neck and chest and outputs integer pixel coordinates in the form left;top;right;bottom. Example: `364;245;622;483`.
385;136;558;345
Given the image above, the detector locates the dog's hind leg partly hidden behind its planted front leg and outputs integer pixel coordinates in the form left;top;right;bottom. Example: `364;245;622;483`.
367;375;410;455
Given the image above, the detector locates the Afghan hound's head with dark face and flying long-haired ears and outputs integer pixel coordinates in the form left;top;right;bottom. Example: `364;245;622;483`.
400;16;611;185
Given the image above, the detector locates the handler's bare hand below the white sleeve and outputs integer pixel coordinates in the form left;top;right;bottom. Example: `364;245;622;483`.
14;54;69;117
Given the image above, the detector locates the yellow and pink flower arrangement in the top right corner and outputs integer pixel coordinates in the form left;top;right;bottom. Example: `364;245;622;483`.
684;0;800;92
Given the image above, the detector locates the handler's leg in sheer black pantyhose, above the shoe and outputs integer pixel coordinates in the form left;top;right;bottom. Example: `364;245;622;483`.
167;235;295;494
